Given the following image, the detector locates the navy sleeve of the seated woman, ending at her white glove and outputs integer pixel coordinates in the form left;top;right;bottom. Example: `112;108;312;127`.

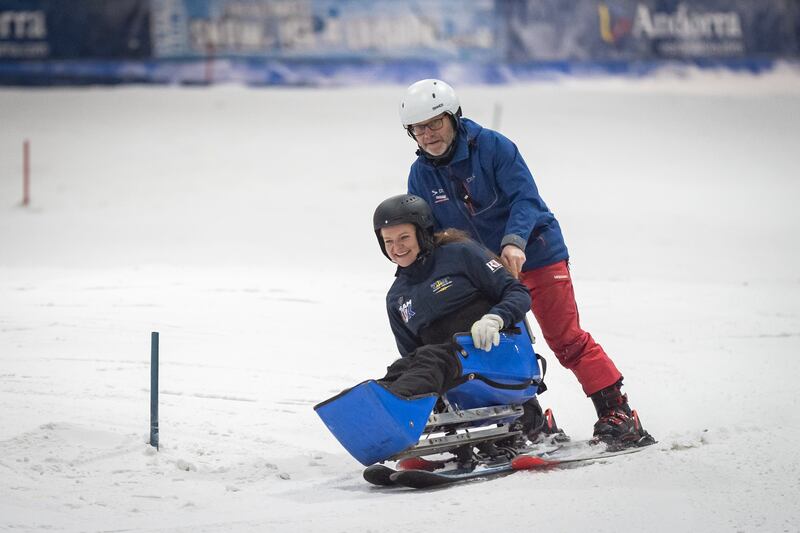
464;243;531;327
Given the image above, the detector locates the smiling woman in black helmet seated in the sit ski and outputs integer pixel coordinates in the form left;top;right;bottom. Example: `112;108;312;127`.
373;194;530;397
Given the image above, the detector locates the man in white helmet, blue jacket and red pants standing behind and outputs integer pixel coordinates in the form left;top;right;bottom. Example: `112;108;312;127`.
400;79;651;445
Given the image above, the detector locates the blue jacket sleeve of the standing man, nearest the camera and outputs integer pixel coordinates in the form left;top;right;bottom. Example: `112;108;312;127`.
492;132;547;250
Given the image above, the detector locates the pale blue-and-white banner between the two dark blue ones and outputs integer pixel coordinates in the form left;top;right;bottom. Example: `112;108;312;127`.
152;0;500;61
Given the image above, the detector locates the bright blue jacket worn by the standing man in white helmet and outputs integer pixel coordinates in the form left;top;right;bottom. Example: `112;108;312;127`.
408;118;569;271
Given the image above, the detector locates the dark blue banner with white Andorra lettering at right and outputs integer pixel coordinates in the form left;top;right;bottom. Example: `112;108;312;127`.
498;0;800;62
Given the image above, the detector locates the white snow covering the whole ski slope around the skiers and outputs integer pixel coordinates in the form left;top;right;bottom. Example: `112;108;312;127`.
0;68;800;532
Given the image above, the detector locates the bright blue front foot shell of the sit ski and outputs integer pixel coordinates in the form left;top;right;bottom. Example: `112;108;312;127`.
314;380;437;466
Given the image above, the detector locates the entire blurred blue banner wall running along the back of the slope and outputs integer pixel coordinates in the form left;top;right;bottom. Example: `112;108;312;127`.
0;0;800;85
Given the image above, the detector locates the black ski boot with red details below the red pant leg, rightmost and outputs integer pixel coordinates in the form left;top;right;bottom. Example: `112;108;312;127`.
590;380;656;450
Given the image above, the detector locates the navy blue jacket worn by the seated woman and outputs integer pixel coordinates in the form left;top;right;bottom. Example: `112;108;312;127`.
386;241;531;356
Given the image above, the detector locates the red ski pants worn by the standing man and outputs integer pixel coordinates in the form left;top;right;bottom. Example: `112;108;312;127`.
520;261;622;396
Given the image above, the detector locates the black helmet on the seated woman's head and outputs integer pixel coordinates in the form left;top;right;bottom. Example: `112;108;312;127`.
372;194;433;259
